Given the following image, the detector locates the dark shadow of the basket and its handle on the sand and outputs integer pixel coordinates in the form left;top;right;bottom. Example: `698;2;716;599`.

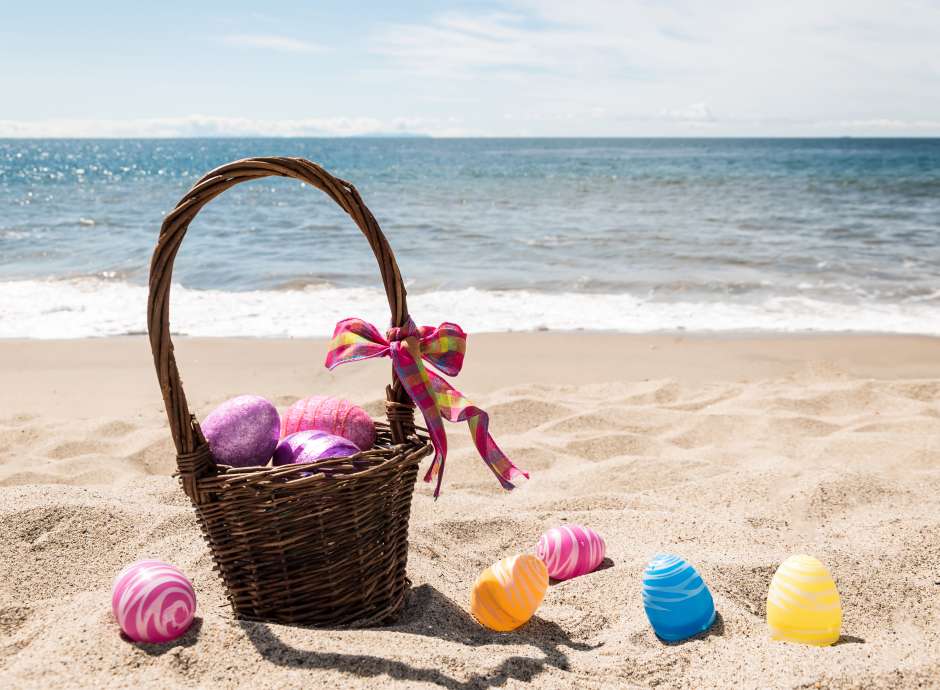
239;585;600;690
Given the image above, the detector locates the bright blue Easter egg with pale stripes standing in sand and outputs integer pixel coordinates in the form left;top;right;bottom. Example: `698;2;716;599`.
643;553;715;642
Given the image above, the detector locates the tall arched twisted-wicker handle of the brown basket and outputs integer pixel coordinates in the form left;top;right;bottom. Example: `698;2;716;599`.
147;157;414;498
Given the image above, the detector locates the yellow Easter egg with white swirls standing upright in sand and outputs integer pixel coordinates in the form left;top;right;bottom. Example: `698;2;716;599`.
767;555;842;646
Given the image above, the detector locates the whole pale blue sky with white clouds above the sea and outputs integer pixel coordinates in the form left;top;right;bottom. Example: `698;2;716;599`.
0;0;940;137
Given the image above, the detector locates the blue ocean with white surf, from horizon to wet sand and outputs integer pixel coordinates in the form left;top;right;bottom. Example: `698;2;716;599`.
0;138;940;338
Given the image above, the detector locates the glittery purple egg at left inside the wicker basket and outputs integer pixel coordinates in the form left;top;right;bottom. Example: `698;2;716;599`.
201;395;281;467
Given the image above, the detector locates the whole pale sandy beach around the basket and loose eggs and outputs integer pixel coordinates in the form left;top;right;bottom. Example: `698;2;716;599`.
0;333;940;688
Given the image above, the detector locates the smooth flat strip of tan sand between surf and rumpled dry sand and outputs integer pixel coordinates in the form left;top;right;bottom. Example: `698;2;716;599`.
0;331;940;418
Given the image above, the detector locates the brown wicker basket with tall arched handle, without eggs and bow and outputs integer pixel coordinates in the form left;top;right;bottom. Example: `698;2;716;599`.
147;158;431;626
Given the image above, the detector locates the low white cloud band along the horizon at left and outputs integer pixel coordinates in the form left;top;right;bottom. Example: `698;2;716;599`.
0;115;475;138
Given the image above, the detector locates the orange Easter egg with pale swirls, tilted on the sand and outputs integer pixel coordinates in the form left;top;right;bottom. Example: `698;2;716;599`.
470;553;548;632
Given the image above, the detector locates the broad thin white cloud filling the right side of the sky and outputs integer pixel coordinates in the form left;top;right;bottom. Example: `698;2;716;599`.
369;0;940;136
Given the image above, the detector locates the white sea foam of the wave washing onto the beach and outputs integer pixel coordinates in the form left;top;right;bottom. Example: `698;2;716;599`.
0;278;940;338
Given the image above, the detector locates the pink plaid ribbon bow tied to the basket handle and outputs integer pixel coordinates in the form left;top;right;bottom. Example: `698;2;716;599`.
326;318;529;498
